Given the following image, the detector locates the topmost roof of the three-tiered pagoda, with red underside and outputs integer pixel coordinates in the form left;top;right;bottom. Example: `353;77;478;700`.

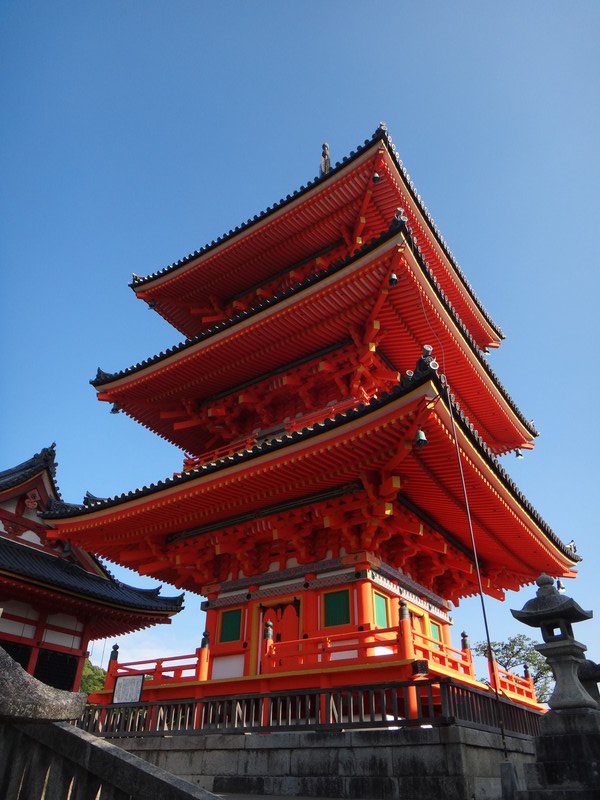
131;127;503;348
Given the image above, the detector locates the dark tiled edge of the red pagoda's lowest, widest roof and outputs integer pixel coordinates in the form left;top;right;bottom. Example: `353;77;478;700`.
41;369;581;561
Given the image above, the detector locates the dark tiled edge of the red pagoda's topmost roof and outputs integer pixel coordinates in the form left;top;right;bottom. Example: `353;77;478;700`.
129;123;504;338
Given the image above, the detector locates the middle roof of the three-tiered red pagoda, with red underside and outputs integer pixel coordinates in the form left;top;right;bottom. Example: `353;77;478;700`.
92;225;536;454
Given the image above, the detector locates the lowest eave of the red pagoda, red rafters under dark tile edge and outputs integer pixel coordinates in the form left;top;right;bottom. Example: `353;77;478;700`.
45;382;575;596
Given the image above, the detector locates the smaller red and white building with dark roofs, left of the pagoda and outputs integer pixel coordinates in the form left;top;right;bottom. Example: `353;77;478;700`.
0;445;183;691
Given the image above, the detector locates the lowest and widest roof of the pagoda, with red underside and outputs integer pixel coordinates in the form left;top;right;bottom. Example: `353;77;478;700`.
45;372;578;594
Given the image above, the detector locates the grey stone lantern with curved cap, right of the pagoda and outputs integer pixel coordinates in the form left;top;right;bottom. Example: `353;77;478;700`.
511;575;598;711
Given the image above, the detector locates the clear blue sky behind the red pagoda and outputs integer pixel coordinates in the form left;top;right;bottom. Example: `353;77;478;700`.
0;0;600;672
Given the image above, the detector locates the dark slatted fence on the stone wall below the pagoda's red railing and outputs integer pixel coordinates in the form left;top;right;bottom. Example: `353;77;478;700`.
79;678;540;738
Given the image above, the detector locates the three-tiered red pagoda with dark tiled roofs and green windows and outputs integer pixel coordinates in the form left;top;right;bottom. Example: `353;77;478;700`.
45;126;577;705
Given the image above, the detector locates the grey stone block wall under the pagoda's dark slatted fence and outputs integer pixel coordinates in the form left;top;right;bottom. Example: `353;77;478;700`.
118;726;534;800
